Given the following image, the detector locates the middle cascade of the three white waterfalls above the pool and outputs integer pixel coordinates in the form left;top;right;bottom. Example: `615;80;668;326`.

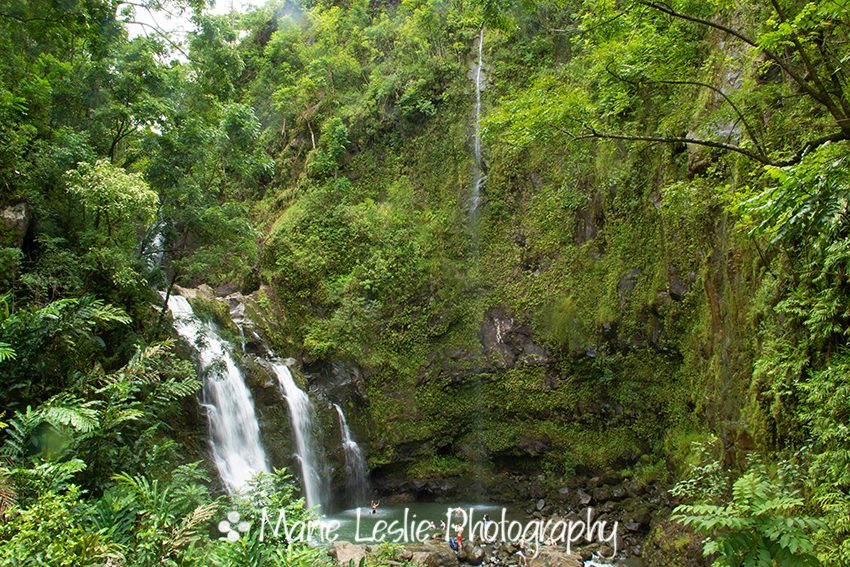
271;361;326;508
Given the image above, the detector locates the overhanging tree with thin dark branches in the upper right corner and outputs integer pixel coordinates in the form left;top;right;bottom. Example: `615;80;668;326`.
567;0;850;166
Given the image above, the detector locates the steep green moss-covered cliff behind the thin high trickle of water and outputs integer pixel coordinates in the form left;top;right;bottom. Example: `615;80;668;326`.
237;2;846;560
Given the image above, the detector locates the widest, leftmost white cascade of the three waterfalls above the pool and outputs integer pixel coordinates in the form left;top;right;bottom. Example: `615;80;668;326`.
163;294;269;492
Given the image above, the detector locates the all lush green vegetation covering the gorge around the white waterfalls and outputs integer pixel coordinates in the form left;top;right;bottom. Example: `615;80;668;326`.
0;0;850;565
